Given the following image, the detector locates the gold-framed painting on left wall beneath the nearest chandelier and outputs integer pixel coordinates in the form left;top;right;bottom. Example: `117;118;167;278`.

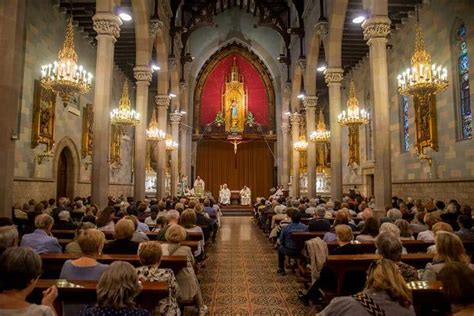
31;80;56;151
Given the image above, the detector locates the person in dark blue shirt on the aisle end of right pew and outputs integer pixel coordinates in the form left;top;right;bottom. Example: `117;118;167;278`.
277;210;308;275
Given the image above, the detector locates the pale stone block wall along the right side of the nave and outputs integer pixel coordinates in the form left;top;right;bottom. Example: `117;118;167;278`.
343;0;474;203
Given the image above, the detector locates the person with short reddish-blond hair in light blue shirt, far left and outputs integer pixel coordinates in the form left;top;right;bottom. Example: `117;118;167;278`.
21;214;62;253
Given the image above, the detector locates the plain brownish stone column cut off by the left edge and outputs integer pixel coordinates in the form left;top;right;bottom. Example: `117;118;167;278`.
0;0;25;217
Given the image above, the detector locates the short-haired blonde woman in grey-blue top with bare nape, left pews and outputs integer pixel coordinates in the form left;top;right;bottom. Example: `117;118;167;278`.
59;229;108;281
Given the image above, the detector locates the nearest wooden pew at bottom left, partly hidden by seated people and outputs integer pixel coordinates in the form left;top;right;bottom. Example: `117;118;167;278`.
28;279;168;315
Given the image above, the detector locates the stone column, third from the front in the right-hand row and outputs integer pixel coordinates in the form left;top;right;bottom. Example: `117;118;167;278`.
303;95;318;198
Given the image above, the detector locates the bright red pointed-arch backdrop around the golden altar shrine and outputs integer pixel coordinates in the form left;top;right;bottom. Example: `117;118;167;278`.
201;54;268;126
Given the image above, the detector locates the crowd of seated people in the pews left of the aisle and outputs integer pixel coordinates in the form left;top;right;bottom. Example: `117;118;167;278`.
0;197;221;315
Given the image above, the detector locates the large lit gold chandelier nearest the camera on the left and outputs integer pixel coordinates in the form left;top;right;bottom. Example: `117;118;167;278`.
41;17;92;106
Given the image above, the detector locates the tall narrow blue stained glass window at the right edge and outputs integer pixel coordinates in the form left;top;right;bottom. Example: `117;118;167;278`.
456;22;472;139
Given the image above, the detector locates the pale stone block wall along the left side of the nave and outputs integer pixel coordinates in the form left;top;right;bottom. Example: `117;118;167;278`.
14;0;135;202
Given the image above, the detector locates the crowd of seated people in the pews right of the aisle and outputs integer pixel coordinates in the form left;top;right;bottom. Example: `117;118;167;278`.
254;192;474;315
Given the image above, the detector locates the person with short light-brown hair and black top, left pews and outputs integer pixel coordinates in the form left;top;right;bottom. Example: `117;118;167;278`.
104;218;138;255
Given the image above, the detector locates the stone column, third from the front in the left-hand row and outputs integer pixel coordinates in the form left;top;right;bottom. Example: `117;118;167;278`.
155;94;170;199
